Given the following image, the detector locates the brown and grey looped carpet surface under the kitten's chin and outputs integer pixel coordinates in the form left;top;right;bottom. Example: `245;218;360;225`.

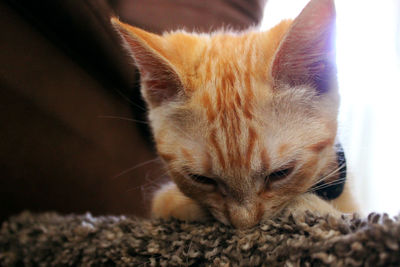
0;212;400;266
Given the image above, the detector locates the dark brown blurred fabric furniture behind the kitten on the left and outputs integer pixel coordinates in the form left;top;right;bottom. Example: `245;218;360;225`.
0;0;264;220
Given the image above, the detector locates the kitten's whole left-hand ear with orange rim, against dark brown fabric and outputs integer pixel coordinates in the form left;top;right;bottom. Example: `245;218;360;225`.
111;18;183;108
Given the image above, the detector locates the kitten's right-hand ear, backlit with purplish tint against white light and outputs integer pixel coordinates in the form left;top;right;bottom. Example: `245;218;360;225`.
271;0;336;93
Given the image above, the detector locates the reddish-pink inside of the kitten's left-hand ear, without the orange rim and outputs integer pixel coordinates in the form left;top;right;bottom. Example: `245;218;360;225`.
121;28;183;106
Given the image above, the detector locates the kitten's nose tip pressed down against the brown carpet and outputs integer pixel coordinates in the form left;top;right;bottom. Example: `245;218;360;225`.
228;202;264;228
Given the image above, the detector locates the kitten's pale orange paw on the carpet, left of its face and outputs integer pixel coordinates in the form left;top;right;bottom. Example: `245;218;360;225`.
151;183;208;221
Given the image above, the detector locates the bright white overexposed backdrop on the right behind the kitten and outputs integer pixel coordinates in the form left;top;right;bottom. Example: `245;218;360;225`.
261;0;400;215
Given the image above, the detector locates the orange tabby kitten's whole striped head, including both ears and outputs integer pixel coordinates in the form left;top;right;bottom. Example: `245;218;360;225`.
113;0;339;227
